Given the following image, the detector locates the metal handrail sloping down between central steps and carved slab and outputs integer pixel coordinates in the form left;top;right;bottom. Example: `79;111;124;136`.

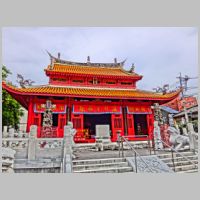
119;136;153;173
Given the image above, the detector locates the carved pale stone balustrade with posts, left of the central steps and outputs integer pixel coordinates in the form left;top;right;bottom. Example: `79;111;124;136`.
2;123;76;173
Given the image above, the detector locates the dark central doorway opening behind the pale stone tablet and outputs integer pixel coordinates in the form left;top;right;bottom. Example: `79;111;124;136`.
83;114;111;138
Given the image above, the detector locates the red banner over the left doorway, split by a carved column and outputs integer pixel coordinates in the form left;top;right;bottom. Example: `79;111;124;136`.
34;103;66;113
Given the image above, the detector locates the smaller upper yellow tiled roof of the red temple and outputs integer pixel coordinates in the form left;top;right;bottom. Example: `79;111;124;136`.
45;63;141;77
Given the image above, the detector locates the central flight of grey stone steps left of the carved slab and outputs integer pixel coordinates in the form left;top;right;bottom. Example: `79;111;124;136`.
73;158;133;173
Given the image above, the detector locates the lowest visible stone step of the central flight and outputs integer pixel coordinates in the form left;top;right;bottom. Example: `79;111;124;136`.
73;167;133;173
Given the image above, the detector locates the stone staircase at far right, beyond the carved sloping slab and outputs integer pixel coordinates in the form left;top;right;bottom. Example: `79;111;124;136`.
157;151;198;173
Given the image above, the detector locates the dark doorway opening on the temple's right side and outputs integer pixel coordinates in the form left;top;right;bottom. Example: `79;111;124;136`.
133;114;148;135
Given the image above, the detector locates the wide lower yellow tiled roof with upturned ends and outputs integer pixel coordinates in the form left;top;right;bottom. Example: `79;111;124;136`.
2;83;180;100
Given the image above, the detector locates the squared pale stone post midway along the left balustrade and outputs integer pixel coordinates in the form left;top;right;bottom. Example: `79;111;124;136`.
28;125;37;160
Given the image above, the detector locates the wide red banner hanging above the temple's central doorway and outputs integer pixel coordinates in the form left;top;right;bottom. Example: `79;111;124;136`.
73;105;121;114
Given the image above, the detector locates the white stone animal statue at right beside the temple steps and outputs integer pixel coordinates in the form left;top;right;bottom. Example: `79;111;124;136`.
167;127;190;151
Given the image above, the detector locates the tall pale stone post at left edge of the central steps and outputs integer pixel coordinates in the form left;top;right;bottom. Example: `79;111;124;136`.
63;125;73;173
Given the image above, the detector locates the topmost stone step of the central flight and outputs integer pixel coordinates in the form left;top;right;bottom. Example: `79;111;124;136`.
73;158;126;166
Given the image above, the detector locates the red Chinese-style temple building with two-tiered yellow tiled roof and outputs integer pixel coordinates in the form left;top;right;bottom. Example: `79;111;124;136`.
2;54;180;142
